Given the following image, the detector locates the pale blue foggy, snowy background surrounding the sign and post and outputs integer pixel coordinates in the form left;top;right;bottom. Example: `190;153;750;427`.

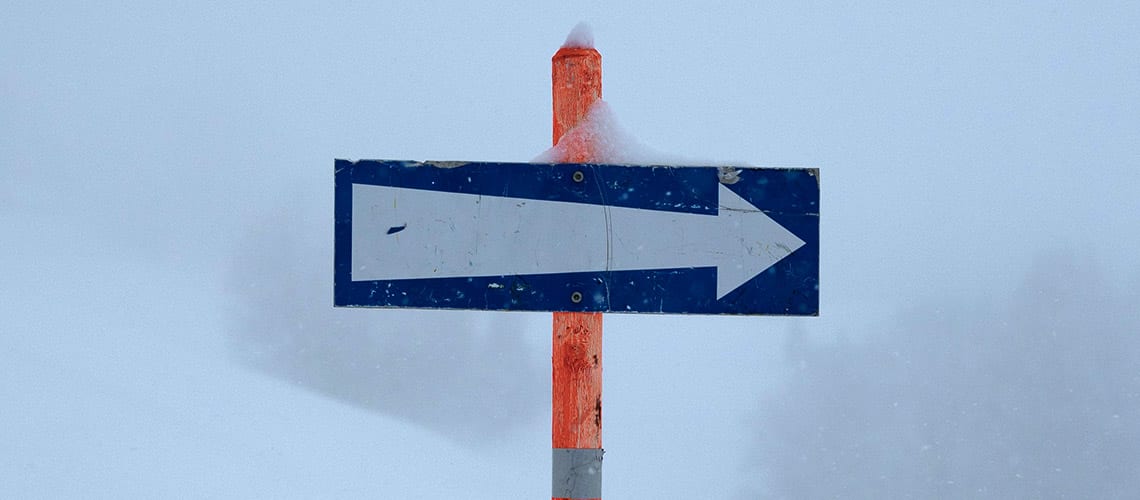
0;1;1140;498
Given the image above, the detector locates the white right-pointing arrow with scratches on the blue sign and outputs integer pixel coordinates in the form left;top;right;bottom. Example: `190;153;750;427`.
352;183;804;300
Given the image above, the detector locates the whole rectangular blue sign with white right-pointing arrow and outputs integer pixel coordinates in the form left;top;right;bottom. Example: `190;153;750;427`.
334;159;820;315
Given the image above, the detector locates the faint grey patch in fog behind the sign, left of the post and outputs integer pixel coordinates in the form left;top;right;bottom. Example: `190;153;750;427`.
229;198;549;444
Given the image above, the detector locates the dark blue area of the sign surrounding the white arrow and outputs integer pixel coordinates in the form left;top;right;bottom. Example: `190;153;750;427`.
333;159;820;315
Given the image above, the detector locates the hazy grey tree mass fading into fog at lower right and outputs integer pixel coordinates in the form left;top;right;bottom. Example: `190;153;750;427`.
746;254;1140;499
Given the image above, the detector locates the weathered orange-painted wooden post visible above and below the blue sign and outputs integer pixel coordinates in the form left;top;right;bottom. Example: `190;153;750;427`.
551;42;602;499
